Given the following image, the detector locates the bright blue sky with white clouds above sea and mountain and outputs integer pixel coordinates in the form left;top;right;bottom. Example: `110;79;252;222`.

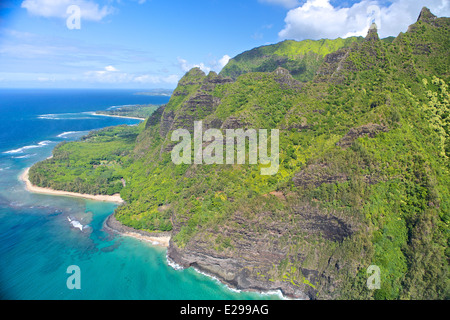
0;0;450;89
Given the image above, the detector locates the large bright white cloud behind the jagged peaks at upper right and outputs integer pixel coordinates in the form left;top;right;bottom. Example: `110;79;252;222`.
278;0;450;40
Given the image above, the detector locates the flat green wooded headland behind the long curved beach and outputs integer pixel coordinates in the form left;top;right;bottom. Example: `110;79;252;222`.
29;124;143;195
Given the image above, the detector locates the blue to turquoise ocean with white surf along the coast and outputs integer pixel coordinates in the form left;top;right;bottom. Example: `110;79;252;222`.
0;89;278;300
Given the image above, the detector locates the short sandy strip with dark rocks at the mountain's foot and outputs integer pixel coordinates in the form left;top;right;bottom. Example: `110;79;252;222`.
103;214;170;248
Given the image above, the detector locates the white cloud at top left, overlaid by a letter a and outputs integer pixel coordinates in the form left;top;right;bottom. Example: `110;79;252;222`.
21;0;114;21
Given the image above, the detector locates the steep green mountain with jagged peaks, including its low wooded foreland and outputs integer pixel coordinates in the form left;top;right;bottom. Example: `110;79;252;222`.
30;8;450;299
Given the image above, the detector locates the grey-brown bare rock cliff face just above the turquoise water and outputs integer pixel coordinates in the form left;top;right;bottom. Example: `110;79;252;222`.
168;200;353;299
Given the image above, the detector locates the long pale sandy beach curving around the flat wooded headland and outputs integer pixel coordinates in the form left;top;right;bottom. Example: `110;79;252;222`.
19;168;125;203
